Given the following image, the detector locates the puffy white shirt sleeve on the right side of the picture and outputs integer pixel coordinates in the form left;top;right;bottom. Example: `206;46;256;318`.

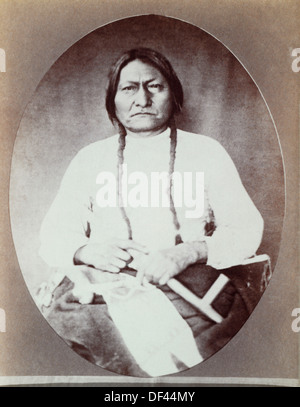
205;143;264;269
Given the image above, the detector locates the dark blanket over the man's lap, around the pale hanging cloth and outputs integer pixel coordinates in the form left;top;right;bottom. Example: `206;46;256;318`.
46;265;249;377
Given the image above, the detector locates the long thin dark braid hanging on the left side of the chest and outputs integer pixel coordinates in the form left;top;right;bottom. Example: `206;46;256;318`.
117;125;132;240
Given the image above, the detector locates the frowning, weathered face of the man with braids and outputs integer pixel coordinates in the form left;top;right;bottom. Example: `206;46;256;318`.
115;60;172;136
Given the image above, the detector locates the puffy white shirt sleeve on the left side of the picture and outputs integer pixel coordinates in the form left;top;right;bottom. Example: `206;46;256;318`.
39;153;89;267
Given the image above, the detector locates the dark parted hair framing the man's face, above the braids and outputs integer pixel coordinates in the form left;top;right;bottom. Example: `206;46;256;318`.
106;48;183;124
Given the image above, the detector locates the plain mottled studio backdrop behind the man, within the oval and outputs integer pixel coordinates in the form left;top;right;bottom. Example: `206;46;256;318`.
10;15;285;376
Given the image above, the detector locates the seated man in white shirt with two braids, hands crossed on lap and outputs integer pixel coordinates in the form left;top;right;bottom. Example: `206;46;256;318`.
40;48;263;376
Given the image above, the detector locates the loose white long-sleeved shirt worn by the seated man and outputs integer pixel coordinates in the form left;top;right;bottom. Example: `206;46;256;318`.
40;129;263;269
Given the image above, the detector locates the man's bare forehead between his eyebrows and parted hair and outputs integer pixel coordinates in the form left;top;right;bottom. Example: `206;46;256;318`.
119;59;166;82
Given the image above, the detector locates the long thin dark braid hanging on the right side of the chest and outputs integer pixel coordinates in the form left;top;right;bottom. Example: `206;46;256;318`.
169;117;182;245
